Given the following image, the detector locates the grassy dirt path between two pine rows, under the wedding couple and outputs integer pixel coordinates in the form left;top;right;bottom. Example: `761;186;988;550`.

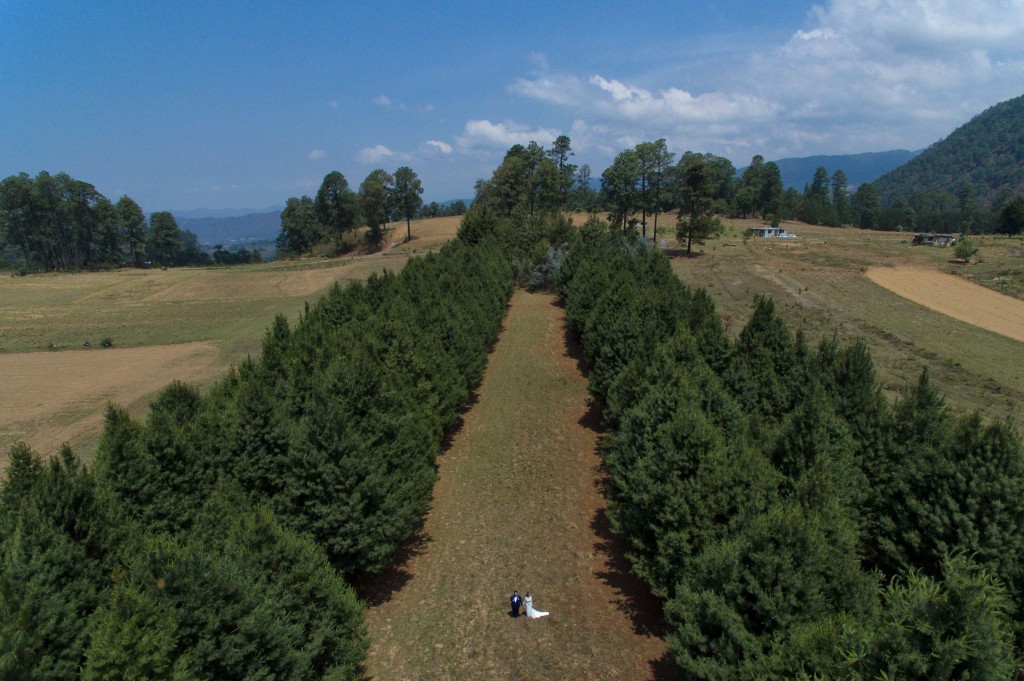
360;292;676;681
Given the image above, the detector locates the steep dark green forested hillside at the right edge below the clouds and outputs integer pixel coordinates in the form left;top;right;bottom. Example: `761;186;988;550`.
874;95;1024;212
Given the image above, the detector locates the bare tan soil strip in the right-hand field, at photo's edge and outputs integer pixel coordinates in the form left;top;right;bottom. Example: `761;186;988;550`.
867;267;1024;341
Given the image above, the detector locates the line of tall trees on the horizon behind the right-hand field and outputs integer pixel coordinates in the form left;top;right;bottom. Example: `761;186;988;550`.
474;135;1024;237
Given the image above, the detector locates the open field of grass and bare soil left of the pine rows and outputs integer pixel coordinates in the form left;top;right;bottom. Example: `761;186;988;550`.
0;217;459;468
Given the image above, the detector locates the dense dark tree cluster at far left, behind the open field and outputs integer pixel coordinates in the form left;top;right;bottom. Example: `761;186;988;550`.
0;171;223;271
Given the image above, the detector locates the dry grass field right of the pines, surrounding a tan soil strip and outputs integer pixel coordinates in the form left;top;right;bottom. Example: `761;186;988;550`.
672;220;1024;425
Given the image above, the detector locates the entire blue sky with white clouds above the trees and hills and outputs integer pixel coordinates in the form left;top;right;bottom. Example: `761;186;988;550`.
0;0;1024;212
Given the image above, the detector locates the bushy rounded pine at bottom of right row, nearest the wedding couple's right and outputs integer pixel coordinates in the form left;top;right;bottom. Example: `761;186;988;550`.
666;502;876;679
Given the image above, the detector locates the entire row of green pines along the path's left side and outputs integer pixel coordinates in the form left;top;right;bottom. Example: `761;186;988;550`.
0;240;513;681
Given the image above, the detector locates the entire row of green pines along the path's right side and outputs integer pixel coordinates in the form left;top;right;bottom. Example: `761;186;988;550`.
558;223;1024;680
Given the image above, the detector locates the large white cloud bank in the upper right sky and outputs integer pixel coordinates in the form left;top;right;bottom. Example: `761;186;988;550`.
507;0;1024;162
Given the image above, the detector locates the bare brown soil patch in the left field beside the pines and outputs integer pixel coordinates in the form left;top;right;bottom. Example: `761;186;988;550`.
0;342;223;467
